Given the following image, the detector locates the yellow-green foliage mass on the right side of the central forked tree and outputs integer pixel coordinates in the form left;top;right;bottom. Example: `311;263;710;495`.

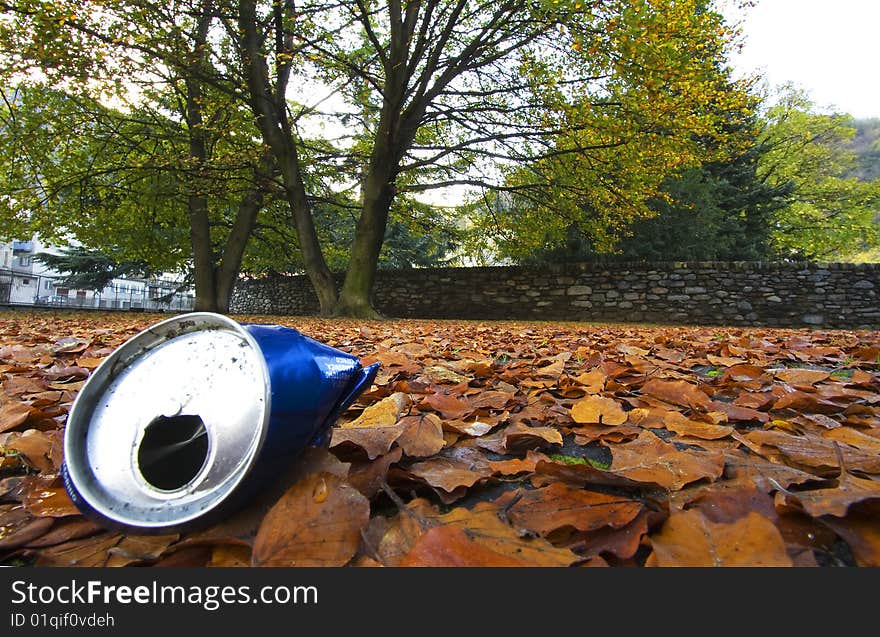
468;0;754;261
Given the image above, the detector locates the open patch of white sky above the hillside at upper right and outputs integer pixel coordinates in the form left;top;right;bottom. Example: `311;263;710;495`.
727;0;880;118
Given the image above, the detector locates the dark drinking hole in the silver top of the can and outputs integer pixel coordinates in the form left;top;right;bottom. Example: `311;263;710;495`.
137;415;208;491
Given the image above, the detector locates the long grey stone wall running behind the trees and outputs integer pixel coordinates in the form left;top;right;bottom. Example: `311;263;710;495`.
232;262;880;329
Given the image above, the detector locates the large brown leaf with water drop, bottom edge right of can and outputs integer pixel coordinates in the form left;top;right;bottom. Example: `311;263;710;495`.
253;473;370;566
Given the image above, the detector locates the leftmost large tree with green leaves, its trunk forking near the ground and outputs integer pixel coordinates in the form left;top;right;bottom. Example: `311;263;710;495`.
0;0;273;312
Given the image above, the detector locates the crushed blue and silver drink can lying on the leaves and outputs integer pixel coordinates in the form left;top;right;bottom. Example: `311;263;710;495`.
61;312;379;533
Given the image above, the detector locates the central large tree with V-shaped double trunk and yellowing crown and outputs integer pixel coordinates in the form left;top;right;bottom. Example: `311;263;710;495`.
228;0;748;316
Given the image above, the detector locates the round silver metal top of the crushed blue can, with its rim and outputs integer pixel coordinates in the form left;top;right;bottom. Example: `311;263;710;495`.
64;312;271;532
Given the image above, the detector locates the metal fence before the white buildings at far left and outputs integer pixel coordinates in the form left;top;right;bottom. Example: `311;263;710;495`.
0;269;195;312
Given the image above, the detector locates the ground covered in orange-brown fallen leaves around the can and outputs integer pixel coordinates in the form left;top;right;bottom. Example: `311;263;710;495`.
0;313;880;566
